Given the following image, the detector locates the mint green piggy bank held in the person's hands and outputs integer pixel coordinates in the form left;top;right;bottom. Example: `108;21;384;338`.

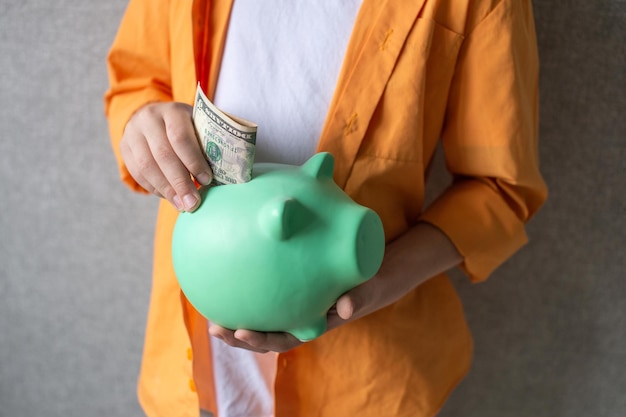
172;153;385;340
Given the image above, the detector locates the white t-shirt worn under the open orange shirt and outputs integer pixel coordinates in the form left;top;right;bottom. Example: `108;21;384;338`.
211;0;361;417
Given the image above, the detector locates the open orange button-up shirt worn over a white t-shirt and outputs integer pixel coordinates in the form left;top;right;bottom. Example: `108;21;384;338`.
105;0;546;417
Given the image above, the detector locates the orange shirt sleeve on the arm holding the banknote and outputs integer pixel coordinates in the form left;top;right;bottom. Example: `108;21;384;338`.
104;0;173;192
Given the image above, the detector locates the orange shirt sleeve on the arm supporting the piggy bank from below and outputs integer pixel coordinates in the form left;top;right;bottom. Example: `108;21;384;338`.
421;0;547;282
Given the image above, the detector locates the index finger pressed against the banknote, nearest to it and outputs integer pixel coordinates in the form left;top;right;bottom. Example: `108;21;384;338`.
164;103;213;185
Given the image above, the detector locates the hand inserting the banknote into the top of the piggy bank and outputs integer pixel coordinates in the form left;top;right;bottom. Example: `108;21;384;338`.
120;103;213;211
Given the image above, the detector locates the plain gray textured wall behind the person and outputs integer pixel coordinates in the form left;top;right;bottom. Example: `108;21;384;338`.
0;0;626;417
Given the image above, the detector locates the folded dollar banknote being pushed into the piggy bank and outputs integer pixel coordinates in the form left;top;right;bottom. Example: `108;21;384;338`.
193;84;257;185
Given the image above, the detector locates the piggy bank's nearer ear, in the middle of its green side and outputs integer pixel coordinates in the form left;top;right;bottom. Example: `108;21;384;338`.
259;197;314;240
